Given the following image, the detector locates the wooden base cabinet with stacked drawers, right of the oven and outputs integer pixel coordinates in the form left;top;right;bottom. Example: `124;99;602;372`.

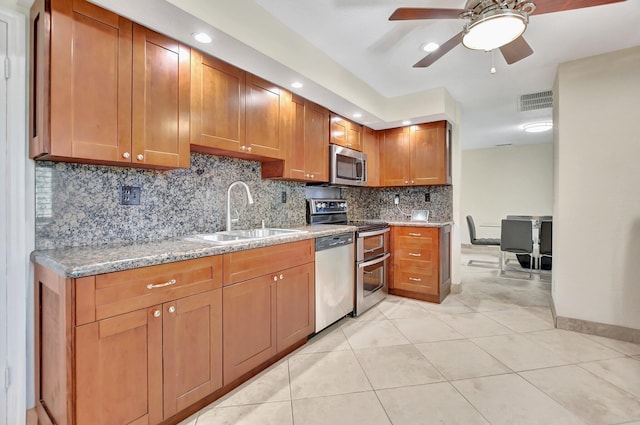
389;225;451;303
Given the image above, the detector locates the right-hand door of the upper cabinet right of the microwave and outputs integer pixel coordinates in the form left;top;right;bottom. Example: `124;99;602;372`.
409;121;448;185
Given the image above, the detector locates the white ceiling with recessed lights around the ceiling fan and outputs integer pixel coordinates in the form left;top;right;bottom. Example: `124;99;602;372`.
92;0;640;149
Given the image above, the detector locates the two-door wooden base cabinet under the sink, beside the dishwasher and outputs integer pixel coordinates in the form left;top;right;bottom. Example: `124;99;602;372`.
222;240;315;385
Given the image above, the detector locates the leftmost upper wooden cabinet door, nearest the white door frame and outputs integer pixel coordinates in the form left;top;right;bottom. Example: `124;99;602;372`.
44;0;132;162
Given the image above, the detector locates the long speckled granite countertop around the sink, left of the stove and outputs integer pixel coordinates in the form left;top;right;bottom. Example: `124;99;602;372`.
31;224;356;278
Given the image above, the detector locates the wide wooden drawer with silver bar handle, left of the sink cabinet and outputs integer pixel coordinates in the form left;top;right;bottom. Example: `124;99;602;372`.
75;256;222;325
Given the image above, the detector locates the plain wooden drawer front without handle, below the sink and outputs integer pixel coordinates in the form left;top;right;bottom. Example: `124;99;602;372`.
224;239;315;285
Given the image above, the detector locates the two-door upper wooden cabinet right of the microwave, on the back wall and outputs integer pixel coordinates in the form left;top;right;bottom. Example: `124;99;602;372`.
380;121;451;186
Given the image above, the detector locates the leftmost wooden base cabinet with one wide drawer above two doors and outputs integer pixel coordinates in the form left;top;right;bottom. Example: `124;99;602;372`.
35;256;222;425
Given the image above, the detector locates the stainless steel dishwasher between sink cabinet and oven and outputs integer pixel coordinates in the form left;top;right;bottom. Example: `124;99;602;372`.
316;233;355;332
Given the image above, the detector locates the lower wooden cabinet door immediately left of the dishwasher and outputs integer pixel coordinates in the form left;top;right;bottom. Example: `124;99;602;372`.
276;263;315;352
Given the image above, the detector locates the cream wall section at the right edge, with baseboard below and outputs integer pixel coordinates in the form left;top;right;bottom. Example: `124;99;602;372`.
553;47;640;329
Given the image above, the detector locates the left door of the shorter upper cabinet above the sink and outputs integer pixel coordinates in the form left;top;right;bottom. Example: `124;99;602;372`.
191;50;246;151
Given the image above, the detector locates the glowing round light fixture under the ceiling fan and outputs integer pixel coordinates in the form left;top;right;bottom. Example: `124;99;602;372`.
462;9;529;51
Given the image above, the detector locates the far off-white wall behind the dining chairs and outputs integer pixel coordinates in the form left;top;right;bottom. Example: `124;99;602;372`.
460;143;553;240
